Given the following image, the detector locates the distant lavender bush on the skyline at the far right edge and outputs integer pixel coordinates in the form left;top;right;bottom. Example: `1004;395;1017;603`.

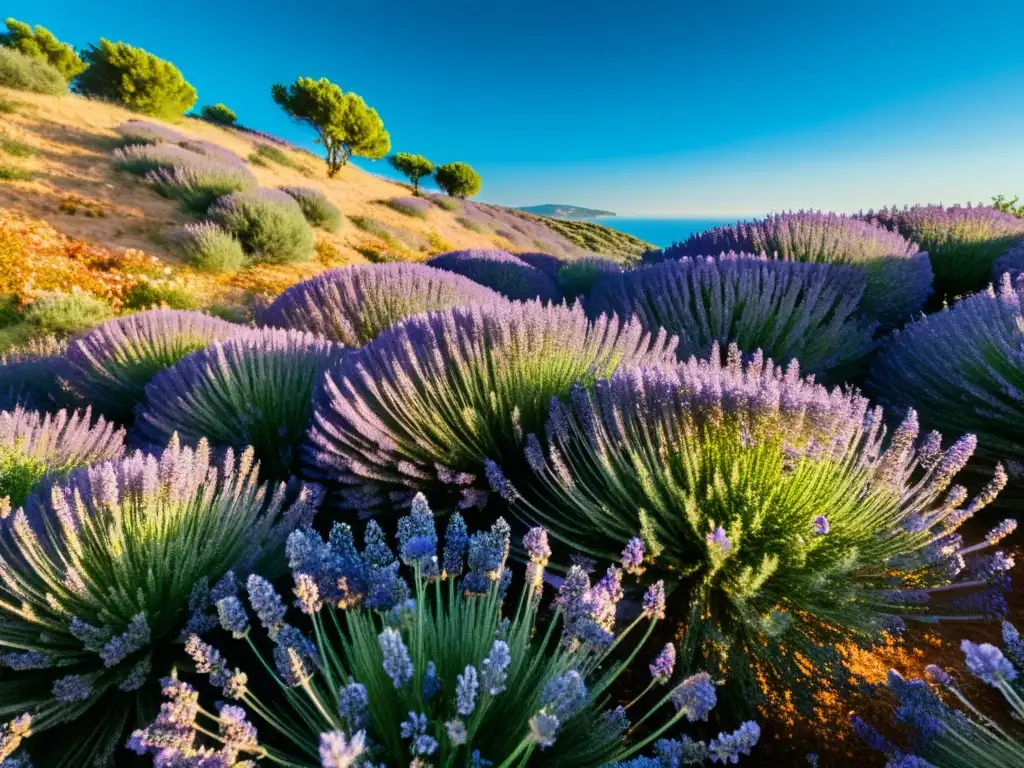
865;206;1024;298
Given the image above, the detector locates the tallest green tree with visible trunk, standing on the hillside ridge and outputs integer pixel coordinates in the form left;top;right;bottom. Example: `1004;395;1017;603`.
270;78;391;176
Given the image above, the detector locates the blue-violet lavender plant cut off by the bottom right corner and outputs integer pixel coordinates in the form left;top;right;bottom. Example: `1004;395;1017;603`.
854;622;1024;768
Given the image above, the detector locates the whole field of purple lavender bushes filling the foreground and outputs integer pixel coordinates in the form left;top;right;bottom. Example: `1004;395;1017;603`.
0;201;1024;767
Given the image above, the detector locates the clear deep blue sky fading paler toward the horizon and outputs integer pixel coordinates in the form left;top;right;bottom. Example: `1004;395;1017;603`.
9;0;1024;216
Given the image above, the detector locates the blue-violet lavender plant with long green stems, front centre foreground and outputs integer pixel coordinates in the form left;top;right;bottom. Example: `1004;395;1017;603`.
129;496;759;766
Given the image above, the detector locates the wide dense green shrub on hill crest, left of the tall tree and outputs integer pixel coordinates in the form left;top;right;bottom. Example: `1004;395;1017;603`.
75;39;197;118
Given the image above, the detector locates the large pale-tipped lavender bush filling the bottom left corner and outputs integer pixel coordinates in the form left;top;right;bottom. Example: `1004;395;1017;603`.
0;440;319;767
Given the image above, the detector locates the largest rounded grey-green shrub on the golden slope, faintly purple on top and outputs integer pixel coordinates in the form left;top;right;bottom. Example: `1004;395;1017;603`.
209;189;313;264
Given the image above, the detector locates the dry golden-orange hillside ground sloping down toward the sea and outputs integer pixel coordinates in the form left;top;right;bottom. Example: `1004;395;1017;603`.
0;88;644;350
